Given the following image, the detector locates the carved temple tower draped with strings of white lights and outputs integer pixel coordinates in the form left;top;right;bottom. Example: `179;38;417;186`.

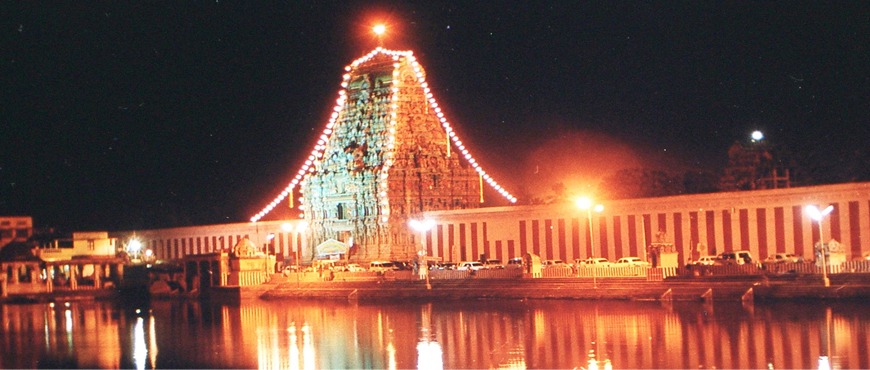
252;48;516;261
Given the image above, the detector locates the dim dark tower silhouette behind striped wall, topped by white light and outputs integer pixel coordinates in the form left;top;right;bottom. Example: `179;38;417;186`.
719;131;791;191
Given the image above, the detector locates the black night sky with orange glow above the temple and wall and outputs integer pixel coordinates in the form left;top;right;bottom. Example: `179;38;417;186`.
0;0;870;231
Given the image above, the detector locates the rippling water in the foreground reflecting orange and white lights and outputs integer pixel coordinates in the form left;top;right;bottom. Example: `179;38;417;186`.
0;300;870;369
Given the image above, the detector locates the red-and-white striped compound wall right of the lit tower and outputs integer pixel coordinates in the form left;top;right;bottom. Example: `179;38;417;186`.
416;183;870;263
